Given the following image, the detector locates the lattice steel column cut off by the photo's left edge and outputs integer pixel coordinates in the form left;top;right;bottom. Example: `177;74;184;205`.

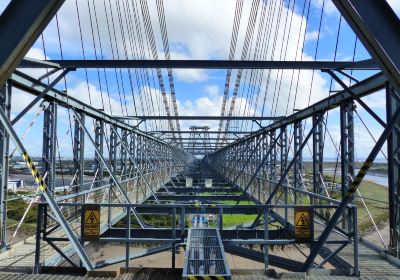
0;82;12;251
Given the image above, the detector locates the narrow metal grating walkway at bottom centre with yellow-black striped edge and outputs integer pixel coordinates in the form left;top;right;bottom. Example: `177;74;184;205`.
182;228;231;279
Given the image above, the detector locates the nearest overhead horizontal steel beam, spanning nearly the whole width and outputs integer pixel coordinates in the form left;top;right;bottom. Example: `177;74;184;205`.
18;59;379;70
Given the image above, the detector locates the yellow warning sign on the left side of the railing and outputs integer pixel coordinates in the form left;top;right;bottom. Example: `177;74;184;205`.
82;204;100;241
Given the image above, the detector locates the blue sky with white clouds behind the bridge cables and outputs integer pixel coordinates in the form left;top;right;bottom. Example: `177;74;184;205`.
0;0;400;159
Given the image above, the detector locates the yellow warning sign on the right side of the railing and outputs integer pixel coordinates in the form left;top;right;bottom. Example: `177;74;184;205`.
294;207;313;243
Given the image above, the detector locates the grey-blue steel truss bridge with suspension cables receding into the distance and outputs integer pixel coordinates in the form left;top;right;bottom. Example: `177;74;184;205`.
0;0;400;279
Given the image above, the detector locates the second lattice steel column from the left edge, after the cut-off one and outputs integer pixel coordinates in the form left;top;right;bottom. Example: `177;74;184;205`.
42;101;57;194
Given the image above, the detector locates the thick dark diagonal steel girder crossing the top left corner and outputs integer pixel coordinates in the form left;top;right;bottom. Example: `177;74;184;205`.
0;0;64;86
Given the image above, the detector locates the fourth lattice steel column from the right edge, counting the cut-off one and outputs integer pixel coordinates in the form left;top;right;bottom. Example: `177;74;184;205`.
293;121;303;204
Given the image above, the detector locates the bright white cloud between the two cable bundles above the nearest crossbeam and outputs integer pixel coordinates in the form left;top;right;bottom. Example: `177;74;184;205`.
159;0;234;59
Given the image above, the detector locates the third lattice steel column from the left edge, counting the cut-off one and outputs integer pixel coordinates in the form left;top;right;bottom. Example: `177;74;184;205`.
73;113;85;196
